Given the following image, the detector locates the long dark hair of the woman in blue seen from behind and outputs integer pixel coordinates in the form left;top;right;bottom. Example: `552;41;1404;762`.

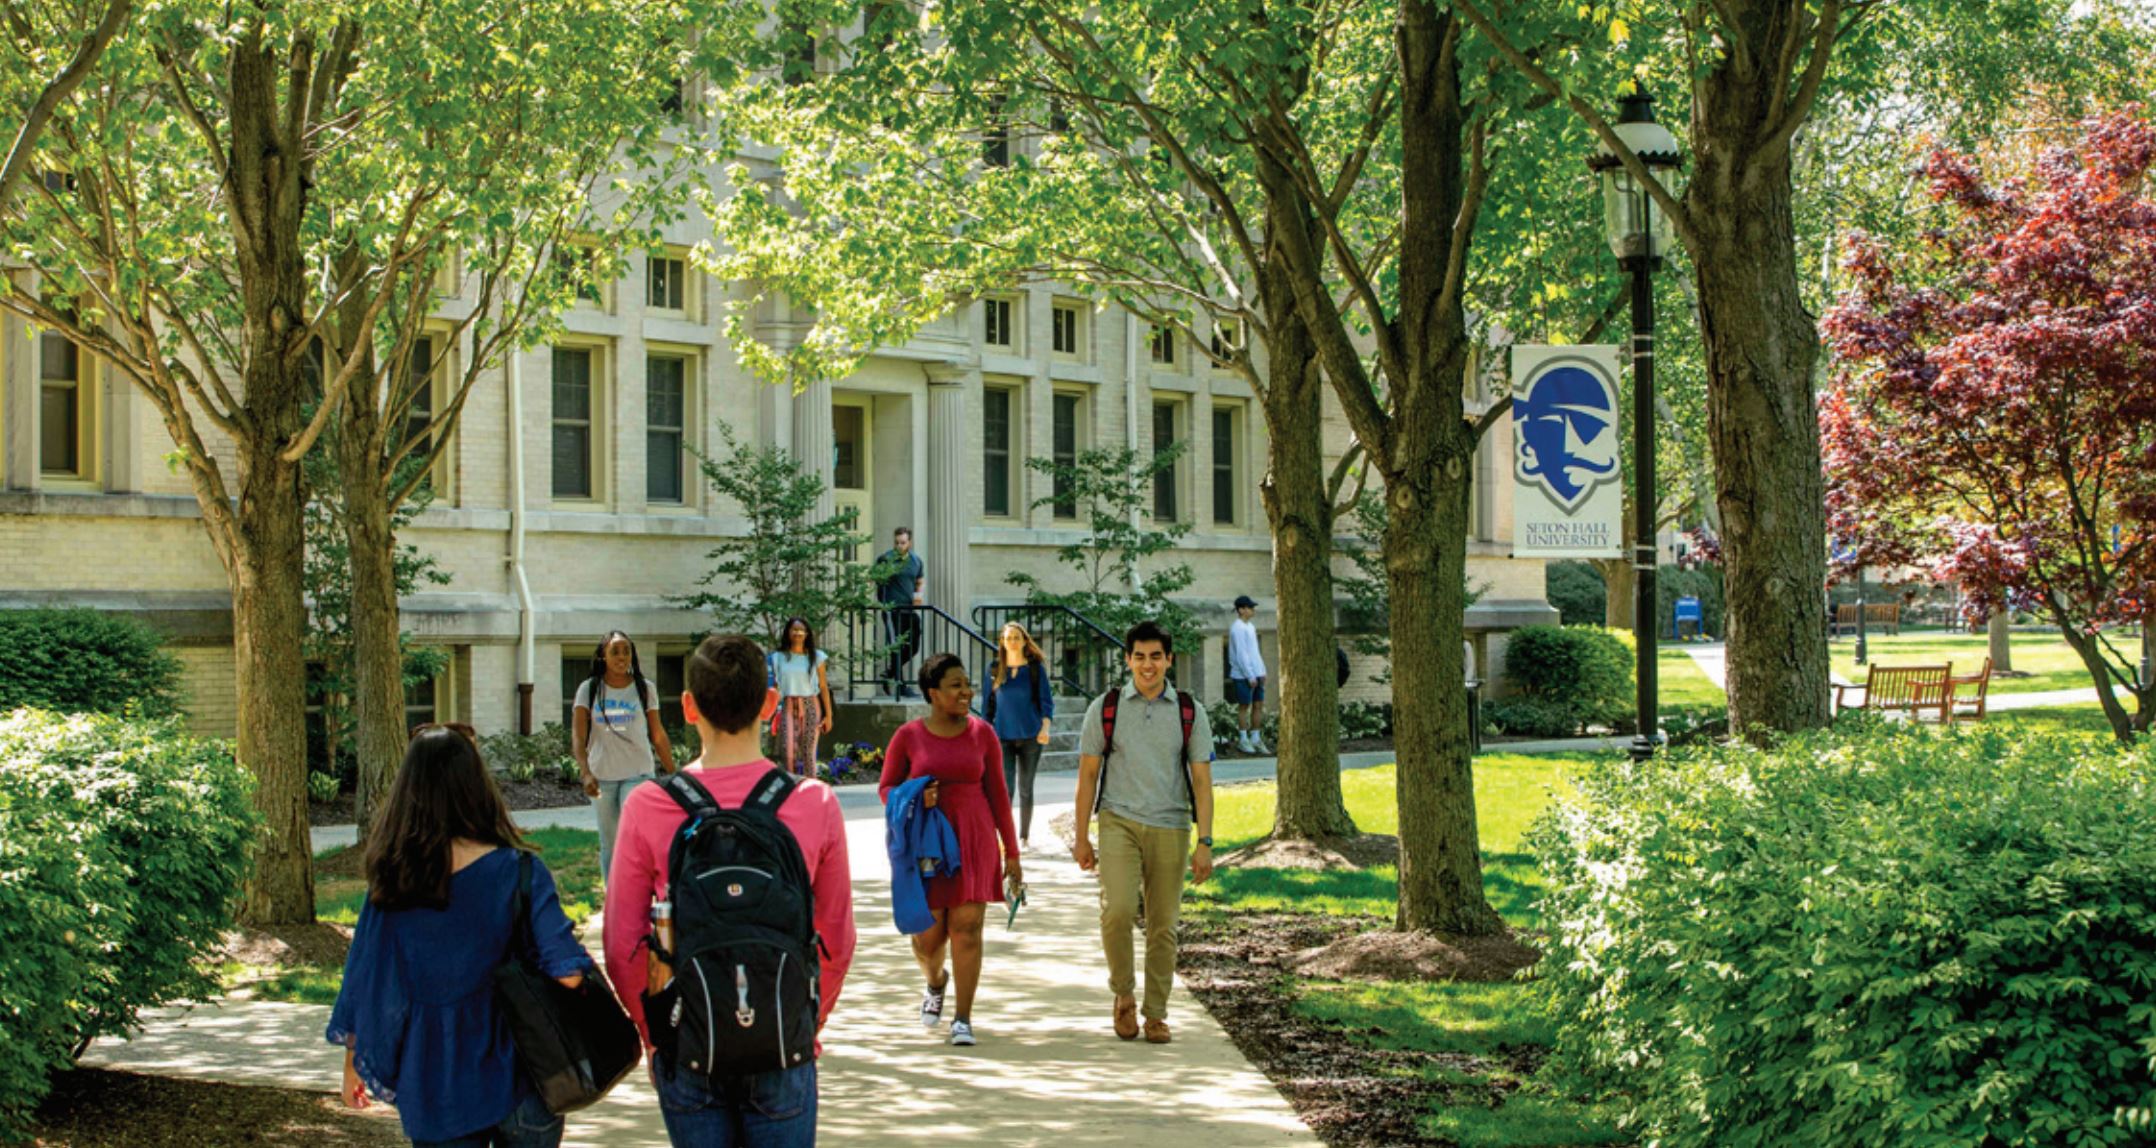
367;725;524;908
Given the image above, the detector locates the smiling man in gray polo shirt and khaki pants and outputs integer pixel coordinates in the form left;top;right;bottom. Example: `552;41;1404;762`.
1072;621;1212;1044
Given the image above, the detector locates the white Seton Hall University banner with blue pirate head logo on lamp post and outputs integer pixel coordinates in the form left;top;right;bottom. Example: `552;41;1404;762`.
1511;345;1626;559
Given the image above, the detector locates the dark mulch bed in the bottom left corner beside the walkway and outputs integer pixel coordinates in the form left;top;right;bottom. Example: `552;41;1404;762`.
30;1068;405;1148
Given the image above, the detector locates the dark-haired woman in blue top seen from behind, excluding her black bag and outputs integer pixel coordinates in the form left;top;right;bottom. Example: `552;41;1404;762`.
328;725;595;1148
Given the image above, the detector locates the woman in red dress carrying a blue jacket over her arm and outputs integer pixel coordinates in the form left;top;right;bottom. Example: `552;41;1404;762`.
875;654;1020;1044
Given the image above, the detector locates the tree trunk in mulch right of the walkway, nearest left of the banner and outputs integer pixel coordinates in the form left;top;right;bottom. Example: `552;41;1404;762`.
1384;444;1505;937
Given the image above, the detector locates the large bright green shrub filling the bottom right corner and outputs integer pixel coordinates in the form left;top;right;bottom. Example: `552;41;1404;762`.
1531;725;2156;1148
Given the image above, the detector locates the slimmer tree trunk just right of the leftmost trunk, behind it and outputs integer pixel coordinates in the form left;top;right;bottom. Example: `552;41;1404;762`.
336;425;405;842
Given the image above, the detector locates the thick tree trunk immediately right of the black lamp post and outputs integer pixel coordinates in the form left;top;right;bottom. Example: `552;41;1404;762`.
1686;132;1828;734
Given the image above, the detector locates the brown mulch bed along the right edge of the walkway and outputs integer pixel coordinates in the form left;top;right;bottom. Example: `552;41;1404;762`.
1177;913;1544;1148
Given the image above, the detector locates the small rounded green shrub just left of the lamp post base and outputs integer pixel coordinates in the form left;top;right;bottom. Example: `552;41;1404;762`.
1485;626;1634;736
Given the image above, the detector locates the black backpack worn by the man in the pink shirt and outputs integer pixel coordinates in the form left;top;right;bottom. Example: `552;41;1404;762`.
647;770;824;1077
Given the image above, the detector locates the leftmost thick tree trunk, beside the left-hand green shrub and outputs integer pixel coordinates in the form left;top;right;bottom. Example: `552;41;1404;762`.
231;431;315;926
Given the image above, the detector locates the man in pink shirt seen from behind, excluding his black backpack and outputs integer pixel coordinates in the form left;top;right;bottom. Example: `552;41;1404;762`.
606;634;854;1148
